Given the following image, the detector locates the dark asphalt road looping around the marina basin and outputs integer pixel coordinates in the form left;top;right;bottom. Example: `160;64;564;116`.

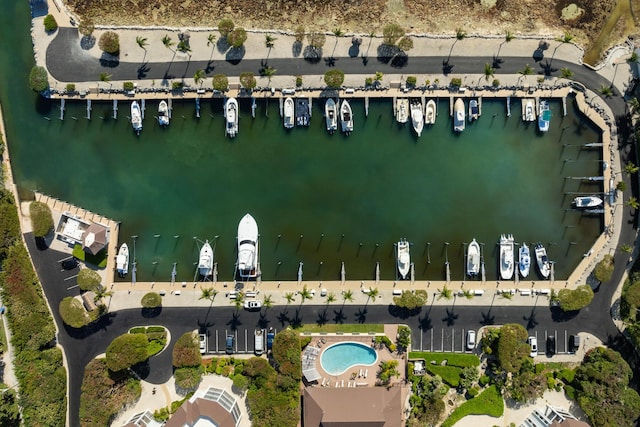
36;28;638;426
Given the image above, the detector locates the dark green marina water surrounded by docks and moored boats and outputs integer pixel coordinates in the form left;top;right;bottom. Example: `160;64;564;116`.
0;0;603;281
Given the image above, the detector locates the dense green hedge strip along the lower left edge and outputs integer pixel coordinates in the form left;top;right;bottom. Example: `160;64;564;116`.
0;190;67;427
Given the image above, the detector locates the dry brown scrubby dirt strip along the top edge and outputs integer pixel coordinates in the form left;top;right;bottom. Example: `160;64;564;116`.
67;0;638;58
